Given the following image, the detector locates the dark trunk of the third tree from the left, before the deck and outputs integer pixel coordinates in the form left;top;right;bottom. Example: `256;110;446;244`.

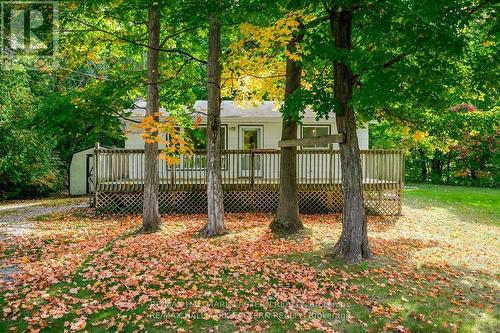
269;30;304;234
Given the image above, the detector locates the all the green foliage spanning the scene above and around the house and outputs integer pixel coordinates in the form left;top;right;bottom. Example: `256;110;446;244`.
0;0;500;197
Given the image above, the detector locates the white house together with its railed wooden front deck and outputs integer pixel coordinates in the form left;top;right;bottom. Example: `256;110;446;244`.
71;101;404;215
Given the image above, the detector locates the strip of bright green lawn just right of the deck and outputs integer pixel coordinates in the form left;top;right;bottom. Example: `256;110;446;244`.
404;184;500;226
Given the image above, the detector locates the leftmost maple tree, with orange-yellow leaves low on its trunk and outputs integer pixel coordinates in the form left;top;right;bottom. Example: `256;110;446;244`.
57;1;206;232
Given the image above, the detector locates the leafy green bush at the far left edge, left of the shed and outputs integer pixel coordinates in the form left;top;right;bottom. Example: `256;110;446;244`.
0;71;62;199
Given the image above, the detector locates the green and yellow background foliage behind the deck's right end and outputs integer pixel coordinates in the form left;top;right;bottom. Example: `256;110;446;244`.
370;104;500;187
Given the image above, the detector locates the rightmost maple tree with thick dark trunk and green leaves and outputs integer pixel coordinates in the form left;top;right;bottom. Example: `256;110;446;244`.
316;1;493;262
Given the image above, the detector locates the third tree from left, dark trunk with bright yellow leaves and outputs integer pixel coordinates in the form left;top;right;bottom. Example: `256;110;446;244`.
223;11;309;233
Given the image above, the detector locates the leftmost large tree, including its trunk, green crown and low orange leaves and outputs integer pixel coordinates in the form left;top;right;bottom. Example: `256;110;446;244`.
63;0;206;232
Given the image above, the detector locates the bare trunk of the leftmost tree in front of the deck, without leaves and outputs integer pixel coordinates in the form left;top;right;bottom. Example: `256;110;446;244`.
142;3;161;232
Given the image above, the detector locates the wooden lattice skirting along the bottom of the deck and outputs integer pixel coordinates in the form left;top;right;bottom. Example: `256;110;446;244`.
95;190;402;215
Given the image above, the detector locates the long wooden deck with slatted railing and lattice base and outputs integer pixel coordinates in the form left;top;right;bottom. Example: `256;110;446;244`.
93;149;404;215
